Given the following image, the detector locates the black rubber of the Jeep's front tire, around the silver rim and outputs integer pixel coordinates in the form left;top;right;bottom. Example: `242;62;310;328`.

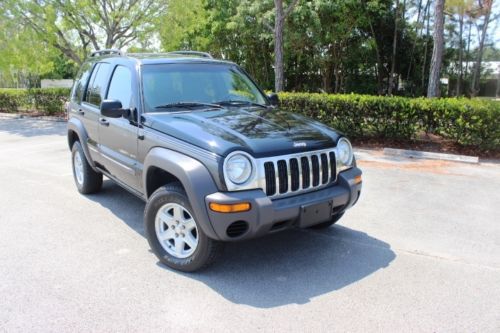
144;184;223;272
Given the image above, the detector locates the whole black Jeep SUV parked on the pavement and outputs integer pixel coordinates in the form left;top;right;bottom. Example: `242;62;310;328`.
68;50;361;271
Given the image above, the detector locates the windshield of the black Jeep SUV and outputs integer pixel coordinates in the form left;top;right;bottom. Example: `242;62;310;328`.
142;64;267;112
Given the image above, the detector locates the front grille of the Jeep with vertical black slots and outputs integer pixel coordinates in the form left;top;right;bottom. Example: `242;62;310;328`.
263;151;337;197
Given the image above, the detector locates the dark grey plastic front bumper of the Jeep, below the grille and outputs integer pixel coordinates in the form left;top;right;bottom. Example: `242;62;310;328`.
205;167;362;241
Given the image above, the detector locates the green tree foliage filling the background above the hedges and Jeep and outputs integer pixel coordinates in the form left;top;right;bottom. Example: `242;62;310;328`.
0;0;500;96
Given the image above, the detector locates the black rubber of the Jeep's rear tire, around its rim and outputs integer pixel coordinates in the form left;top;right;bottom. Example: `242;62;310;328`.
71;141;102;194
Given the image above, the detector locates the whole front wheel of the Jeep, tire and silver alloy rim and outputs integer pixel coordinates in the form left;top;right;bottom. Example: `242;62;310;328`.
144;185;222;272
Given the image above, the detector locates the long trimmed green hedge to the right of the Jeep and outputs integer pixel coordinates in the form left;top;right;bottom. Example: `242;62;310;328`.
279;93;500;149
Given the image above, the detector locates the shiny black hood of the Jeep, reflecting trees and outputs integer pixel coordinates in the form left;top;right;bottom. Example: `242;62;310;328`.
143;107;339;158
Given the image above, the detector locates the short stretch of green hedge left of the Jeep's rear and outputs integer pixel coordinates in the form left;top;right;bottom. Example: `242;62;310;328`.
0;88;70;115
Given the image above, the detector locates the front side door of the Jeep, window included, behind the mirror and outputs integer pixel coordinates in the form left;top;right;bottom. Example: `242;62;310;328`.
99;65;140;191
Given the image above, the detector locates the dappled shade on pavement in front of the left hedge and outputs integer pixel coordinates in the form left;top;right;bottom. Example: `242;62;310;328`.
0;118;66;137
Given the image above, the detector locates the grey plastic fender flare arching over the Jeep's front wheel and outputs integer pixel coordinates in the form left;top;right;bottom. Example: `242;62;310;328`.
142;147;218;239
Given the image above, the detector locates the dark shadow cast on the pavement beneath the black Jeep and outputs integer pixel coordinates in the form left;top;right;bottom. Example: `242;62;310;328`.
89;180;396;308
